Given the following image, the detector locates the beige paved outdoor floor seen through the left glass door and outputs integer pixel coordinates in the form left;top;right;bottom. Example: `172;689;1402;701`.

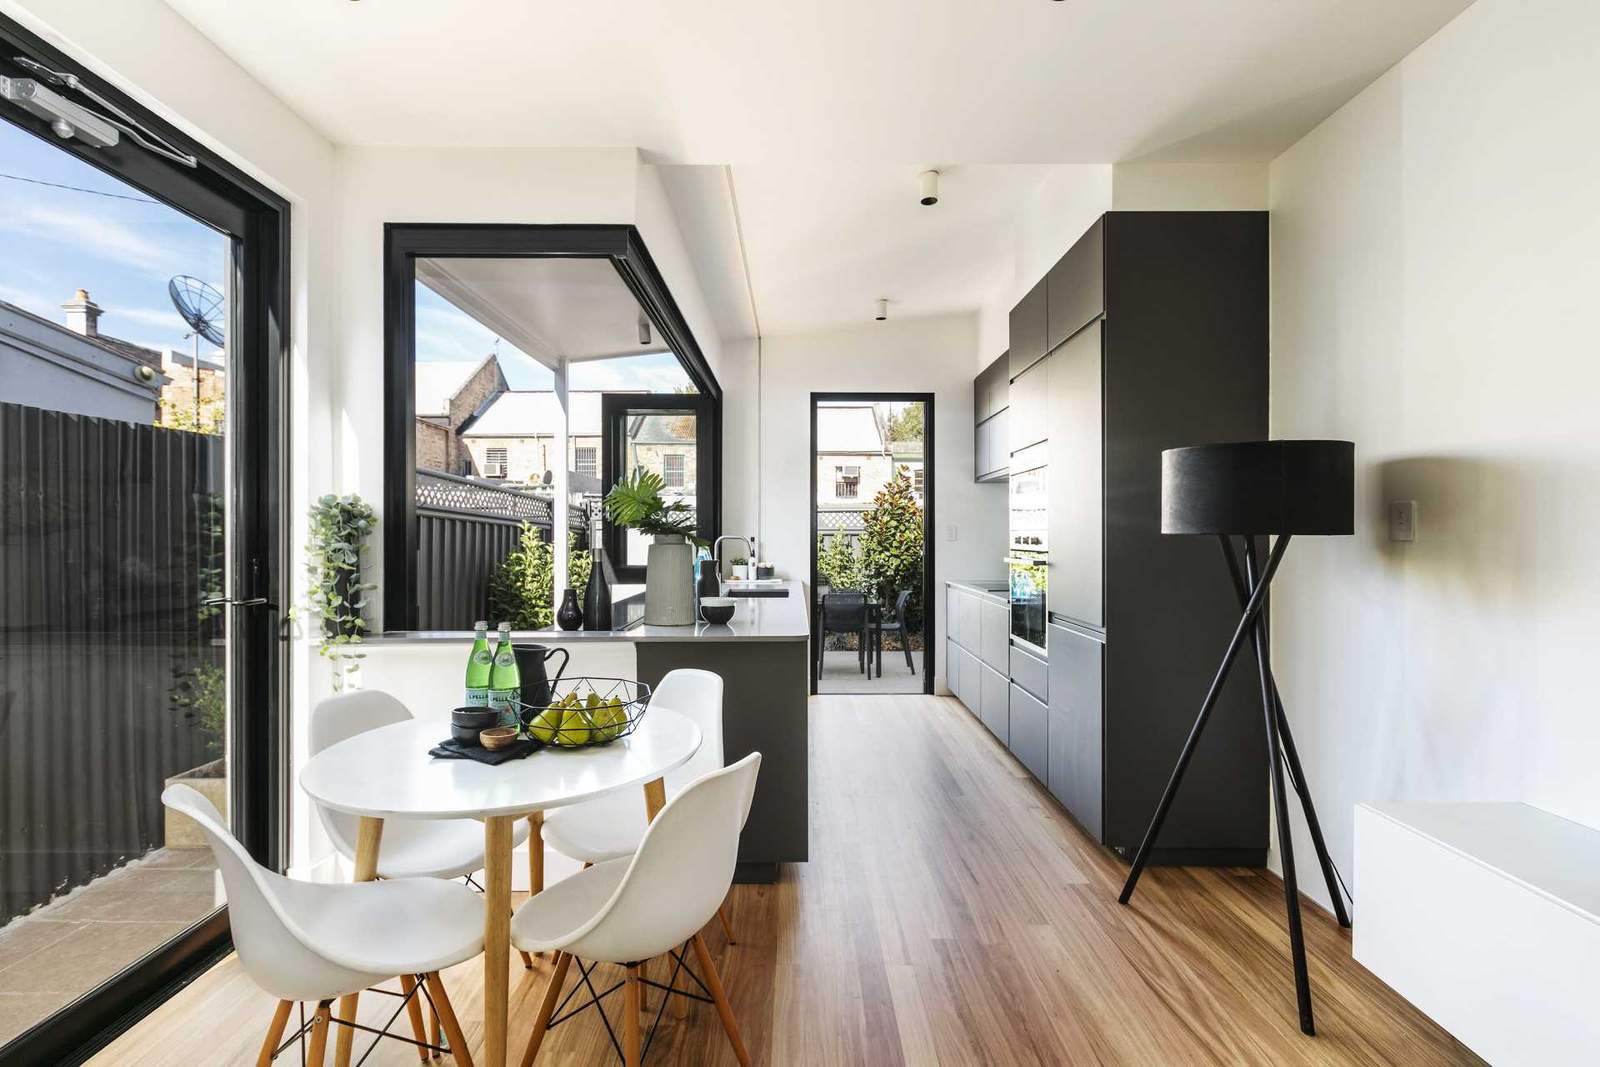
0;851;220;1045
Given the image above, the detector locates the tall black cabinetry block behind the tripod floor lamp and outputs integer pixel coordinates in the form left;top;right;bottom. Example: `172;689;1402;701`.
1043;211;1267;865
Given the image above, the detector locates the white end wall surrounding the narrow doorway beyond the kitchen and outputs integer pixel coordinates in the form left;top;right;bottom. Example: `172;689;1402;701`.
760;315;1006;685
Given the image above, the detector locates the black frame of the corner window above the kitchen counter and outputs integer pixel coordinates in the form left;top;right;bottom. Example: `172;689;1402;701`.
382;222;722;633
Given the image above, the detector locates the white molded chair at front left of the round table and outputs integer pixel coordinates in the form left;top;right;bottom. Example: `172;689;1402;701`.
162;785;483;1067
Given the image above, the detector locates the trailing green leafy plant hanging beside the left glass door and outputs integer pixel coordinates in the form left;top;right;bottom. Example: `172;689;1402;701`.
306;494;378;691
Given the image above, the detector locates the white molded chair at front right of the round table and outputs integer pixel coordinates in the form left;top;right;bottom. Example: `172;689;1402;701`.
510;752;762;1067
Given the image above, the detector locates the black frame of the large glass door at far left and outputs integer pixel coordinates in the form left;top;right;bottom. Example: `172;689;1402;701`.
0;14;290;1067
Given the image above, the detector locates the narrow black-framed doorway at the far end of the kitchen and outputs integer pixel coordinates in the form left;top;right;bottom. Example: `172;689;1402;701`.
806;392;936;694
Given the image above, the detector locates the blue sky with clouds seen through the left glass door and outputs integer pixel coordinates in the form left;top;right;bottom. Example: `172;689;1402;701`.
0;120;229;355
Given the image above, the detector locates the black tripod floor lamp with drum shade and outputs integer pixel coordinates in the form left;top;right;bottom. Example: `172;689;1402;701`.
1118;442;1355;1033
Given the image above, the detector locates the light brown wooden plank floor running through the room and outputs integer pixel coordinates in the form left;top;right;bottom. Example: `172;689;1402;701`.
93;696;1478;1067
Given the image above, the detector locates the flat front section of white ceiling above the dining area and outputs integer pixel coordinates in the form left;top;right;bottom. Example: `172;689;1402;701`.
159;0;1469;163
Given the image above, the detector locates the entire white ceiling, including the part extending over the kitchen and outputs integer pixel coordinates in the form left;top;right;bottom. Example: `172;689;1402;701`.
166;0;1470;336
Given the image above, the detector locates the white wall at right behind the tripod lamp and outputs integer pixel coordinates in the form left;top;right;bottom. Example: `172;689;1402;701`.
1270;0;1600;899
